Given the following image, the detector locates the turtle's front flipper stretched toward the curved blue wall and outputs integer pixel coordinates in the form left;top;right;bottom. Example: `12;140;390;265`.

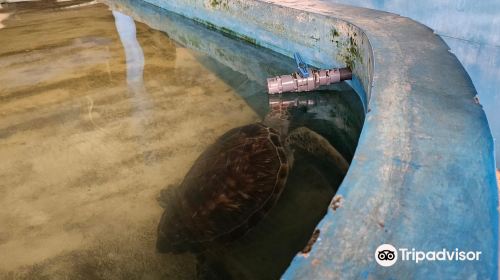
285;127;349;174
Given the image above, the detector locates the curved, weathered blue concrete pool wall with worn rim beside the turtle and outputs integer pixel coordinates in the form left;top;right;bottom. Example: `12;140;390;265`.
132;0;498;279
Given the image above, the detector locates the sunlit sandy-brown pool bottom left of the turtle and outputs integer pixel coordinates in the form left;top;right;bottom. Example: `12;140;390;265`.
0;1;258;279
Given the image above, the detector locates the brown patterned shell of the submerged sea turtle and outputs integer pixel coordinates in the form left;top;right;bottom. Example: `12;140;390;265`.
157;123;289;252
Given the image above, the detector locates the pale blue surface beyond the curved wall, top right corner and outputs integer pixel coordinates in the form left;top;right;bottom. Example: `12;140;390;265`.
323;0;500;166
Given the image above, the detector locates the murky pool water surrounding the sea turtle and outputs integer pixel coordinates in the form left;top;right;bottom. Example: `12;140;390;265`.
0;0;363;279
